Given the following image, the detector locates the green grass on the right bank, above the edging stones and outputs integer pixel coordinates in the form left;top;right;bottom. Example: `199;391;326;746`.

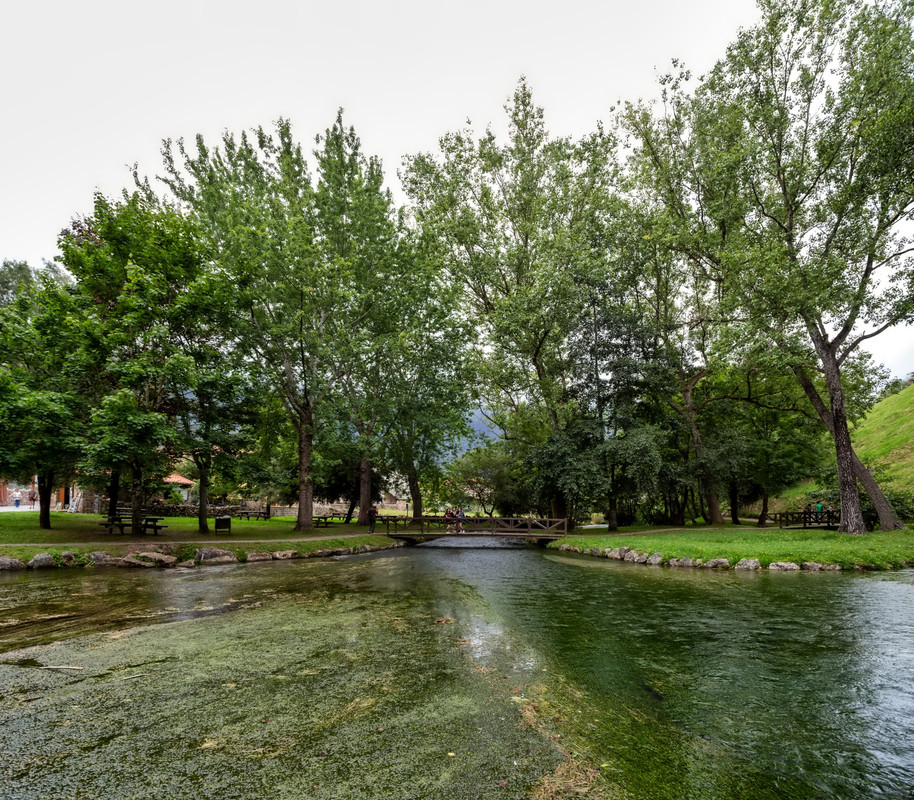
550;525;914;569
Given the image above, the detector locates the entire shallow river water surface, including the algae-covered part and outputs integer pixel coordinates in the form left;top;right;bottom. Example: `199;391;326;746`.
0;540;914;800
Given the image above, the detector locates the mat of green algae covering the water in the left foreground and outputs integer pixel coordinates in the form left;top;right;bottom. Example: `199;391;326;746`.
0;565;561;800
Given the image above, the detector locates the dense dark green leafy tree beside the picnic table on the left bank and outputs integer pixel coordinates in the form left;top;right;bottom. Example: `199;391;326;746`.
59;193;203;531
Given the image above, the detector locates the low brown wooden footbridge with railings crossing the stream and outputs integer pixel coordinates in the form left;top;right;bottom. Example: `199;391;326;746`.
378;516;568;543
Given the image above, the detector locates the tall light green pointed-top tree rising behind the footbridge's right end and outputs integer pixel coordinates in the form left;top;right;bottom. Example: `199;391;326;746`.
405;80;614;516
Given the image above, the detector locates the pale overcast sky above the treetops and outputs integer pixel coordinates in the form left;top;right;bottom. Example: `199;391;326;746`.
0;0;914;376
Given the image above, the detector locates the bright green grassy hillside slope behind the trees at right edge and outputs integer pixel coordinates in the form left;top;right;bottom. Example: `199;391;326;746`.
851;384;914;492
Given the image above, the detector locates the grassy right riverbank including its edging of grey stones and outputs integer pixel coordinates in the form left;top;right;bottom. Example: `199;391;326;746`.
549;526;914;570
